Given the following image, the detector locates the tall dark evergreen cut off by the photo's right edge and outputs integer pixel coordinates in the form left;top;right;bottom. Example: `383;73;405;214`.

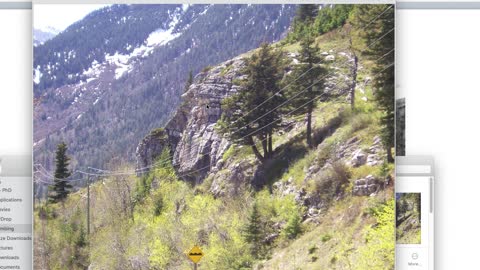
352;5;395;162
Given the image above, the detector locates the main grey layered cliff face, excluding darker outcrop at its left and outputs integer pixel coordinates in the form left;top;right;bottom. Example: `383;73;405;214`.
170;58;244;183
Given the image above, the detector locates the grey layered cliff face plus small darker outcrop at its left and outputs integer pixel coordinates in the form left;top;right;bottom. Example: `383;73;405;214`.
136;58;244;183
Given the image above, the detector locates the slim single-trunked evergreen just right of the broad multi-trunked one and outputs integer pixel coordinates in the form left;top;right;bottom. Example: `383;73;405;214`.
287;35;326;147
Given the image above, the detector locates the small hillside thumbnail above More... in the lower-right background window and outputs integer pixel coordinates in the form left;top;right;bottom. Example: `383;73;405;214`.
396;193;422;244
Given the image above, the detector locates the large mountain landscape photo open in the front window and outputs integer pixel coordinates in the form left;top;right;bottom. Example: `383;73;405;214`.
32;4;394;270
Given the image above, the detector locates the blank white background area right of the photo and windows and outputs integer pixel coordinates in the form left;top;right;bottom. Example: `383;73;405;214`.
396;7;480;270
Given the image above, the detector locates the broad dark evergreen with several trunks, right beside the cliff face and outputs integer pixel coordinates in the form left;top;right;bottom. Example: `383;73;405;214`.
219;43;285;162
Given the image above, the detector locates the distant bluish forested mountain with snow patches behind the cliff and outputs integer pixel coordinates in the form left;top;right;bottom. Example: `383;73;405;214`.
34;5;296;169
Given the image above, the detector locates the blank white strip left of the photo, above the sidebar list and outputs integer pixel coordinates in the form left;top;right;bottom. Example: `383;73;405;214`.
0;10;32;156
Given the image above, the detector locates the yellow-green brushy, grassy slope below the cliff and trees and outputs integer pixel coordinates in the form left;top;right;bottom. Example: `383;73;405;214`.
35;97;394;269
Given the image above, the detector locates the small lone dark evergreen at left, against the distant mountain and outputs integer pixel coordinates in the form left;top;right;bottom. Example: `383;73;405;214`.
49;142;72;203
